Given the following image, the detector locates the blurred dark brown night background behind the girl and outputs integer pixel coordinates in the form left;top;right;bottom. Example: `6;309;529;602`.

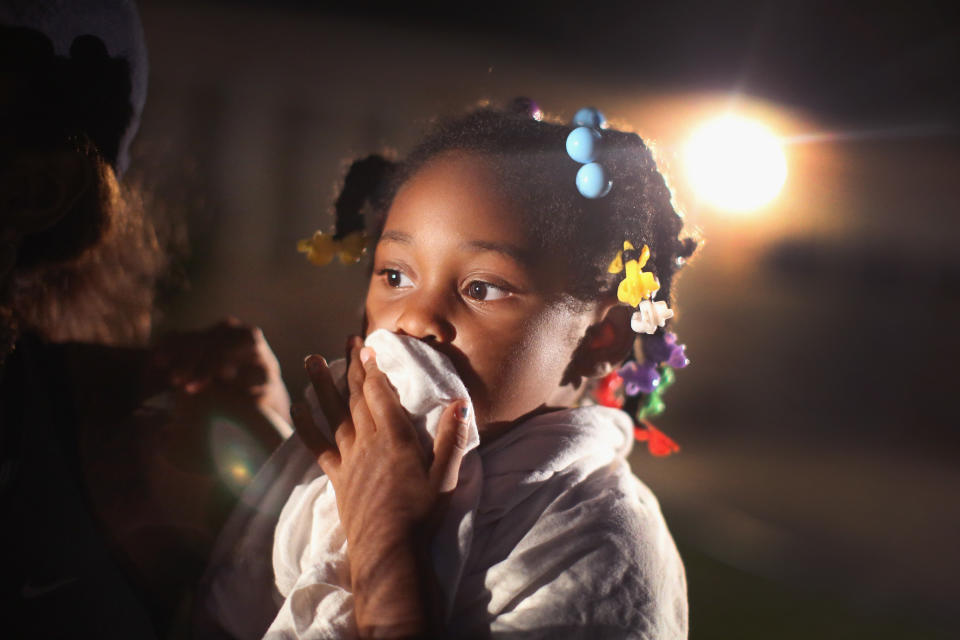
125;0;960;640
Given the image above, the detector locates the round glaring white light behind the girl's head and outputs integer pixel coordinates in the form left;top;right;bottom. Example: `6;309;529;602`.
684;116;787;211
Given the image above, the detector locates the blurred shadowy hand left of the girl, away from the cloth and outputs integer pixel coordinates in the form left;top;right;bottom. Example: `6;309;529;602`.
150;318;290;420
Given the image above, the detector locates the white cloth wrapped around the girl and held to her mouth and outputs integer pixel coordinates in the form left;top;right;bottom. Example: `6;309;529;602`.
204;332;687;640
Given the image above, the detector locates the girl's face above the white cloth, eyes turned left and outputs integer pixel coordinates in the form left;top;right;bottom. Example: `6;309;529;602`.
366;153;595;433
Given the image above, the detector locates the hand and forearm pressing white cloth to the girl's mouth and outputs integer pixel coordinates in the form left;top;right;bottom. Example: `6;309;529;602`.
293;339;469;634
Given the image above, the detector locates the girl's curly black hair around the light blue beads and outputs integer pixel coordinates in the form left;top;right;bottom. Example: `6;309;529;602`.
326;100;697;308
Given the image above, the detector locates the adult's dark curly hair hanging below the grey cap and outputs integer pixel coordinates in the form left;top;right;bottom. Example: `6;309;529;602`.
0;25;167;350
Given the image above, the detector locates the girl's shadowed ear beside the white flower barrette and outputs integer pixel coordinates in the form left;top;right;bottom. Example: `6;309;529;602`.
566;304;637;386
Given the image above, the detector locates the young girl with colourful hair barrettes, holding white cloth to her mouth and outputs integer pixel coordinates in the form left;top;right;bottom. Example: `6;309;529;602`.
202;103;695;639
